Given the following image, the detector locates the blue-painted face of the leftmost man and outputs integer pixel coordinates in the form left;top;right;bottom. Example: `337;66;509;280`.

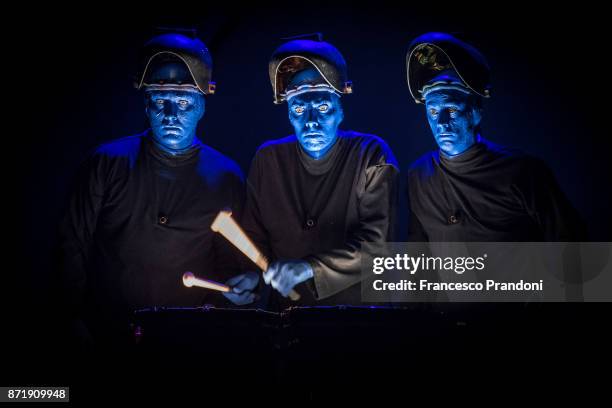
146;90;205;154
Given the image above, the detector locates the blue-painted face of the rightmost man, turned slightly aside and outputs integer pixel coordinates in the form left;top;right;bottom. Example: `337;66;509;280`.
425;89;481;156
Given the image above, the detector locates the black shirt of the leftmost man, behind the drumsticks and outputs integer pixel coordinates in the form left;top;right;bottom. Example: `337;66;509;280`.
60;132;244;338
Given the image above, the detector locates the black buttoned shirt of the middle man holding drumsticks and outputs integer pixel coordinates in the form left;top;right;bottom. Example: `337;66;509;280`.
243;131;398;307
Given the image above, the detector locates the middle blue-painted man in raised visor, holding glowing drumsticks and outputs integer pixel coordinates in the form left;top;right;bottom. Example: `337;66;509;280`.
225;36;399;308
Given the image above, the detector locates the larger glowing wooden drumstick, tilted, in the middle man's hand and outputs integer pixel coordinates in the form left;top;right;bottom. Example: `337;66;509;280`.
210;211;300;301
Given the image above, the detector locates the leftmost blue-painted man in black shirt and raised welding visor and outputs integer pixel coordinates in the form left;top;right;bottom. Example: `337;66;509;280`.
60;33;244;343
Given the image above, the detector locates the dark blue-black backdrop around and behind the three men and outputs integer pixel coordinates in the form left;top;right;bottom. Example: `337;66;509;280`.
6;3;612;396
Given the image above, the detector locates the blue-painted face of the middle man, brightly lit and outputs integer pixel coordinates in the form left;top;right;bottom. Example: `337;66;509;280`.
287;91;344;159
